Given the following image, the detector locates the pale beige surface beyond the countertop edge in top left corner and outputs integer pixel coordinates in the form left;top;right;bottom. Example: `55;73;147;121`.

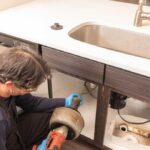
0;0;31;10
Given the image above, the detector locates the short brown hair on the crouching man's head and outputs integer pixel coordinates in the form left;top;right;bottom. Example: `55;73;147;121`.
0;48;50;88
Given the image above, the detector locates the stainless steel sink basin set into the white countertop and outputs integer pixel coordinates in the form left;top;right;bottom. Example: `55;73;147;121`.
69;23;150;59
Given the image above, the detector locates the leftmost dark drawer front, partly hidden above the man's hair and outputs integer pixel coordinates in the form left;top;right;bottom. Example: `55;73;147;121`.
0;34;38;52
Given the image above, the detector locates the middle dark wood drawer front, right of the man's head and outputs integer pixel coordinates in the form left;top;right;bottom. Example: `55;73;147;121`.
42;47;104;83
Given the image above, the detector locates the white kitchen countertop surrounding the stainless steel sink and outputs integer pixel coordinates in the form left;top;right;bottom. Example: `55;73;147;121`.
0;0;150;77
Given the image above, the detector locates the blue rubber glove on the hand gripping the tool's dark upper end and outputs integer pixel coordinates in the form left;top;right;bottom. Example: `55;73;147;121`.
65;93;83;107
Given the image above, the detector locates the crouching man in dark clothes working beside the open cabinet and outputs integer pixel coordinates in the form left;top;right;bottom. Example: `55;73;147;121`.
0;48;82;150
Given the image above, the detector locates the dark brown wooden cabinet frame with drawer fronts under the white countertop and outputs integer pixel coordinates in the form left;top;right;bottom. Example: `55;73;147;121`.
0;34;150;150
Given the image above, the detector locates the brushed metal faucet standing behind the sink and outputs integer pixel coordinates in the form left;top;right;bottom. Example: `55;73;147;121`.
134;0;150;27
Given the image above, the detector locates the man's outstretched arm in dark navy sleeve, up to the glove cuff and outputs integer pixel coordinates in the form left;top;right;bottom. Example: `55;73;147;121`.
14;94;65;112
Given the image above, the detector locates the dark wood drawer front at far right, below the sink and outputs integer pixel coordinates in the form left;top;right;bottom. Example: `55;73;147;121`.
105;66;150;101
